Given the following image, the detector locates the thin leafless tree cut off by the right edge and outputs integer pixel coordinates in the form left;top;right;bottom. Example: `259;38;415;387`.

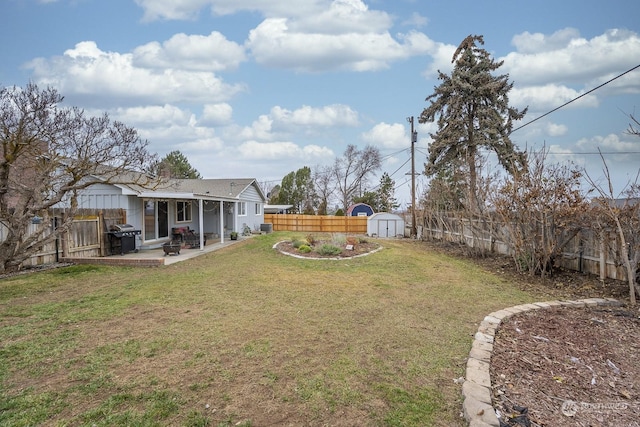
585;149;640;306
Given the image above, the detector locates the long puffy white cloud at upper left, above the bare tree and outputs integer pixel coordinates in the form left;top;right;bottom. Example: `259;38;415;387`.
28;41;244;105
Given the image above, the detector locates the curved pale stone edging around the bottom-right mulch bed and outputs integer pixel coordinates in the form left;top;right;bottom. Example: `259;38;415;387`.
462;298;622;427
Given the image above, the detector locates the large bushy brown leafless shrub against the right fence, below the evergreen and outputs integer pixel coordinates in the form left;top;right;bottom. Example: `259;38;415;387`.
492;149;588;277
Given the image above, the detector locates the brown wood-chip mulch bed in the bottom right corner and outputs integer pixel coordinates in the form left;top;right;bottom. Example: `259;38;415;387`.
491;307;640;427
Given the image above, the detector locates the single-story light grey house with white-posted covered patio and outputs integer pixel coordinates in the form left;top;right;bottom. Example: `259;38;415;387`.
78;178;267;249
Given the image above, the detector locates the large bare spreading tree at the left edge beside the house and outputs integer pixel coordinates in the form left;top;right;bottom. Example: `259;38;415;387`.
0;83;156;273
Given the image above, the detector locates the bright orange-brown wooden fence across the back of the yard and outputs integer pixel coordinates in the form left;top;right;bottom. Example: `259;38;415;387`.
264;214;367;234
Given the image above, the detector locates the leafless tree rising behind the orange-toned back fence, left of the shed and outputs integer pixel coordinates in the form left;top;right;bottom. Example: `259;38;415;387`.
333;144;382;211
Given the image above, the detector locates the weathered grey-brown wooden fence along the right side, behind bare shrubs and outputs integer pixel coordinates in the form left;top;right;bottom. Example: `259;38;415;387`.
419;213;627;280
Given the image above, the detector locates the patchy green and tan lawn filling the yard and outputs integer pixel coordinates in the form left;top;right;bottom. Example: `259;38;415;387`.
0;233;536;426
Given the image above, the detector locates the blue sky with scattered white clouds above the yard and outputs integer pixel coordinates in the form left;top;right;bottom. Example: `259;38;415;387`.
0;0;640;205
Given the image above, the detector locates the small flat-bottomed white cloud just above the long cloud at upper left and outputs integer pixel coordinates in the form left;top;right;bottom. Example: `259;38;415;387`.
133;31;246;71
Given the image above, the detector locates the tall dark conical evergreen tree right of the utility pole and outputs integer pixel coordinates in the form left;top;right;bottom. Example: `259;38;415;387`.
419;35;527;211
